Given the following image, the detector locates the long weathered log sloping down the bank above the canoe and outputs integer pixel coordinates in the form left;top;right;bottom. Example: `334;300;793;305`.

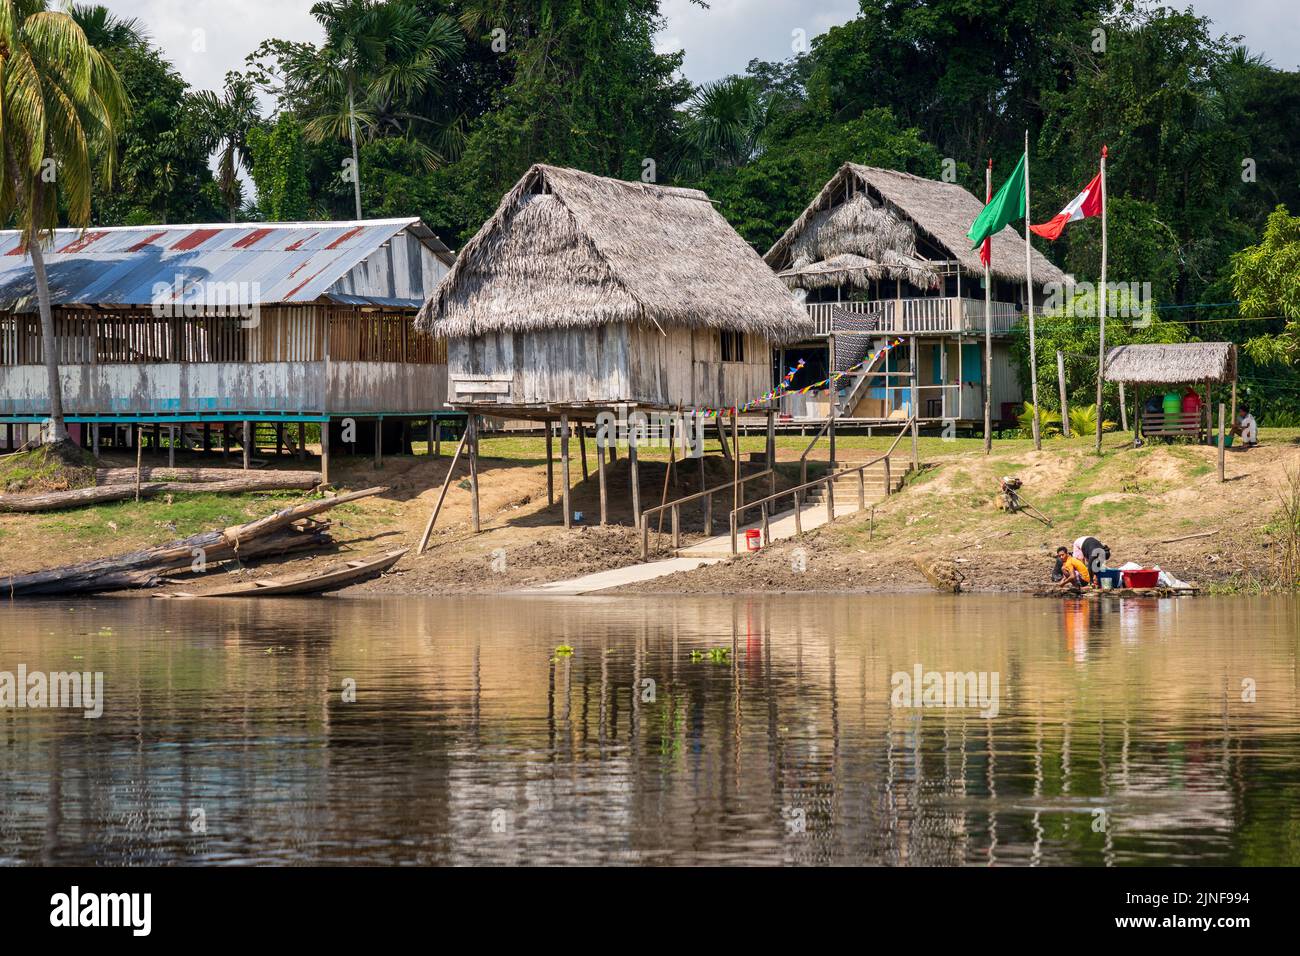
0;488;387;597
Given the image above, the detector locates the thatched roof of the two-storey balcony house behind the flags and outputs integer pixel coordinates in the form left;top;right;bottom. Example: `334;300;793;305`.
764;163;1065;285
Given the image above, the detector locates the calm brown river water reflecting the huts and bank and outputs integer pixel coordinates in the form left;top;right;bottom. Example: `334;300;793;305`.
0;594;1300;865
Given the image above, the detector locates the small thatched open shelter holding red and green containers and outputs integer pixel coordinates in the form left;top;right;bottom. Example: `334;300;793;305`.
1105;342;1236;441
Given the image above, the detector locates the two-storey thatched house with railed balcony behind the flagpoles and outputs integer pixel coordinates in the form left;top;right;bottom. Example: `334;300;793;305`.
764;163;1065;427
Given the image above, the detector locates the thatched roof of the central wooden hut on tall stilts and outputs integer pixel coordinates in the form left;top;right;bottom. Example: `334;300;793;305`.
416;165;813;339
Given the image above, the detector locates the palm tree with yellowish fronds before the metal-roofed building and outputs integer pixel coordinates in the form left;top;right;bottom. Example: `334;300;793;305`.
0;0;127;444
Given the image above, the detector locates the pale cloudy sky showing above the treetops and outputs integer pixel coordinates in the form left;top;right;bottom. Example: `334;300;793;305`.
114;0;1300;95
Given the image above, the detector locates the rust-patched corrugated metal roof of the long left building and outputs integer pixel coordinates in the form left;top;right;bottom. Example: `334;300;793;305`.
0;219;452;312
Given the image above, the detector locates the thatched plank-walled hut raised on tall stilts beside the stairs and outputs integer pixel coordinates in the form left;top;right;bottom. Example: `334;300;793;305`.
416;165;811;530
